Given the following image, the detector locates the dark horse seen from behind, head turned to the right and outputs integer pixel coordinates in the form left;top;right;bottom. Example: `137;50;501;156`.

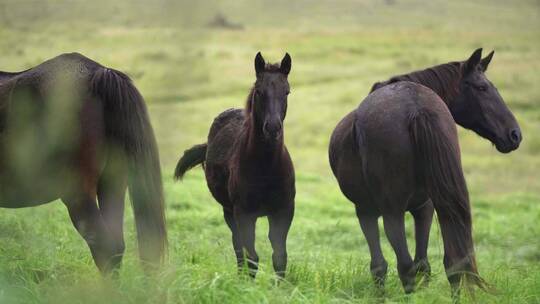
329;49;521;294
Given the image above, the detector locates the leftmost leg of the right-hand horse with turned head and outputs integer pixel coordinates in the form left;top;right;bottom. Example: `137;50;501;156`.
356;207;388;288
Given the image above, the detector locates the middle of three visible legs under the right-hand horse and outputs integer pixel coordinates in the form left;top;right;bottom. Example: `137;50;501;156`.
383;213;416;293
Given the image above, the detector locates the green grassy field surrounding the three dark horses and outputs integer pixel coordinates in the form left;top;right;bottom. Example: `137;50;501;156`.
0;0;540;303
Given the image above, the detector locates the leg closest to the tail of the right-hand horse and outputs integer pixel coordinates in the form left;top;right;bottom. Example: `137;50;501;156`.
411;200;433;284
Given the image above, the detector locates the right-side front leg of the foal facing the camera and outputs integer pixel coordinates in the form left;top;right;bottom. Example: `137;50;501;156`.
268;205;294;278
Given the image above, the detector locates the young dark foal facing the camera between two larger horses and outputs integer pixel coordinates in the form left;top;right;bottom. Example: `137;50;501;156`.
175;53;295;277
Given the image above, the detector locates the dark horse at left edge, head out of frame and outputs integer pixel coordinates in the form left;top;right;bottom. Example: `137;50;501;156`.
0;53;167;273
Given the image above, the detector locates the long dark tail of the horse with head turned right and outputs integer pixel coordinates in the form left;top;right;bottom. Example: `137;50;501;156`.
409;109;487;290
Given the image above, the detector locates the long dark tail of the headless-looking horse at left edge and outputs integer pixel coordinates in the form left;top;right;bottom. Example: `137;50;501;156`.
91;67;167;265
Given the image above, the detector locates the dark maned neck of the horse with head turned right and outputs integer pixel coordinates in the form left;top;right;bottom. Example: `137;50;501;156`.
370;61;463;104
